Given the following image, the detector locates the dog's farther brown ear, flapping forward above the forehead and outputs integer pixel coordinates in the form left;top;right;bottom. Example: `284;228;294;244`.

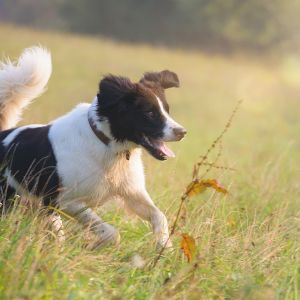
140;70;179;89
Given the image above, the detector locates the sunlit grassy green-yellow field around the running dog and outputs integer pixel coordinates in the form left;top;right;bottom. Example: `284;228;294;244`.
0;24;300;300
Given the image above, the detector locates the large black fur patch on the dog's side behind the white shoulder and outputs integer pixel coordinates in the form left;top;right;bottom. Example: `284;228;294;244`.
2;125;60;205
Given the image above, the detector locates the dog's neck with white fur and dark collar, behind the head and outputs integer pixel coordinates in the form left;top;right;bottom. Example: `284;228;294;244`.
88;97;137;159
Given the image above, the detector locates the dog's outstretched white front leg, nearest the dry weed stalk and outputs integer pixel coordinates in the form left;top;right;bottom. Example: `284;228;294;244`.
124;191;172;250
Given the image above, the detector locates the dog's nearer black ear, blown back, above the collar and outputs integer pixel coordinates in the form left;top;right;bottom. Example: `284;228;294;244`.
97;75;135;107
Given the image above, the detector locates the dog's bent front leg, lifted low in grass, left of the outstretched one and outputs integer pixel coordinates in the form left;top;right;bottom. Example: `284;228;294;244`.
62;202;120;250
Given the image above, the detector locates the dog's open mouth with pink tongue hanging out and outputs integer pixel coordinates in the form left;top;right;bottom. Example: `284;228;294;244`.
141;136;175;160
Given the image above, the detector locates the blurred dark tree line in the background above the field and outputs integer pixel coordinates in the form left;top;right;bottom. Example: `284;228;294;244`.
0;0;300;51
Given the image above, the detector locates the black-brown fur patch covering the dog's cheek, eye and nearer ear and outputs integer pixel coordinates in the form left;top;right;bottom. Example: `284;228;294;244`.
98;76;165;159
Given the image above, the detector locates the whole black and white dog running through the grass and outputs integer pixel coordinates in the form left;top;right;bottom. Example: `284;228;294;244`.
0;47;186;247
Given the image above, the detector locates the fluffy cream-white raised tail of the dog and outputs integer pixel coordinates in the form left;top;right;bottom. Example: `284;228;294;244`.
0;47;52;130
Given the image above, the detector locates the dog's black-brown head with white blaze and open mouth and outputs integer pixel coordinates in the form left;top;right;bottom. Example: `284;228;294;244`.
97;70;186;160
